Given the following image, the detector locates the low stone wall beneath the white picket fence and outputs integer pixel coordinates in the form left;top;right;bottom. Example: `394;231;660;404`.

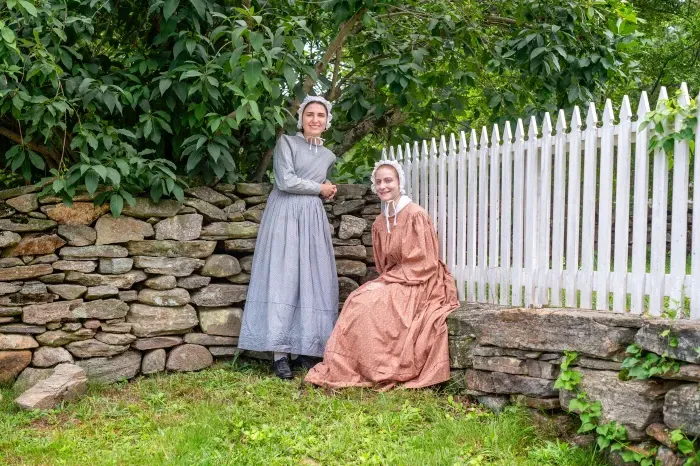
448;304;700;464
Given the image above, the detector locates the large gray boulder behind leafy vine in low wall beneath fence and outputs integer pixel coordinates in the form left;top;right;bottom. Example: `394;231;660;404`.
559;369;677;440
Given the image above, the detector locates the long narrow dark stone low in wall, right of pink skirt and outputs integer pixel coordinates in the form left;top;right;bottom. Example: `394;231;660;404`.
466;369;557;398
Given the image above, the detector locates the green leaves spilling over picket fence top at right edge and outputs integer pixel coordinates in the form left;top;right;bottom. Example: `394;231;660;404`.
639;90;698;170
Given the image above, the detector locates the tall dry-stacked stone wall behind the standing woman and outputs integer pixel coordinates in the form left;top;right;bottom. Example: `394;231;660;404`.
0;184;379;387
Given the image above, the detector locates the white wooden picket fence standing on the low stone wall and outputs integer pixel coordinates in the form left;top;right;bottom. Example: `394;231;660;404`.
386;84;700;319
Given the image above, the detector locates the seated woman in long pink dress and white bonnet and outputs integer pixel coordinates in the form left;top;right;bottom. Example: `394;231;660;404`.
306;160;459;389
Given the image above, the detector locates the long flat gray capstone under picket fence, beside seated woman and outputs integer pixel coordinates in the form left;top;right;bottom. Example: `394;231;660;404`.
448;308;635;358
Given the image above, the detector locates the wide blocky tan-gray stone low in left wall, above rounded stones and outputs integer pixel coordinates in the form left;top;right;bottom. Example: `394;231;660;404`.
127;303;199;337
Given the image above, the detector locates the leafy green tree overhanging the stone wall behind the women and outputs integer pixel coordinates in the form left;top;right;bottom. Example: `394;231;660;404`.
0;0;637;209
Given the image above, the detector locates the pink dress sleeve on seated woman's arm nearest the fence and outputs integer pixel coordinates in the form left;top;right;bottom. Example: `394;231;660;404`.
382;212;440;285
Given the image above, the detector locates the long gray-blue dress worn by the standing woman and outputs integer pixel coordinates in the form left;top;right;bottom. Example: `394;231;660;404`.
238;133;338;356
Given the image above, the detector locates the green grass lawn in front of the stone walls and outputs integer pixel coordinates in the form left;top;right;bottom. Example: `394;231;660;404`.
0;361;605;466
